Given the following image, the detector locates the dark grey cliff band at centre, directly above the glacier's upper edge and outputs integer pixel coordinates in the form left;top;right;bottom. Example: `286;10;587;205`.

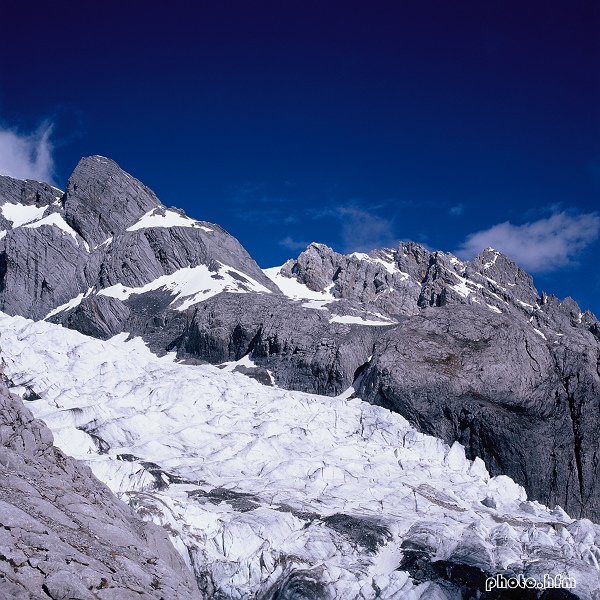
168;294;377;395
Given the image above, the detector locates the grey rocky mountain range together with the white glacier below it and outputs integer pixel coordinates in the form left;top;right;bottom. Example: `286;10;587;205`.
0;156;600;600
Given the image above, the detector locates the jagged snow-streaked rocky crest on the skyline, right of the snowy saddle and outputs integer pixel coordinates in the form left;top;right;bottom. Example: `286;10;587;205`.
281;242;538;315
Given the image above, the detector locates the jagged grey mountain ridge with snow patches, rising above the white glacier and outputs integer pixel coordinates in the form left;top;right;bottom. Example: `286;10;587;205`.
0;157;600;519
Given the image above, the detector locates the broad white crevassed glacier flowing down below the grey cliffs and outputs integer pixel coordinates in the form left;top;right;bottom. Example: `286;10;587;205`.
0;314;600;600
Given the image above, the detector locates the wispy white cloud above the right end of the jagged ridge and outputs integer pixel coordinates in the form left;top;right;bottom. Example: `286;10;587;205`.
456;211;600;273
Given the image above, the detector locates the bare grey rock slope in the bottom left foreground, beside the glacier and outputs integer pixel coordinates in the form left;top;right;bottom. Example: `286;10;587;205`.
0;383;200;600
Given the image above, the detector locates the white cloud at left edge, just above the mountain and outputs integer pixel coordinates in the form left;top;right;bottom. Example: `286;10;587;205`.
0;123;54;183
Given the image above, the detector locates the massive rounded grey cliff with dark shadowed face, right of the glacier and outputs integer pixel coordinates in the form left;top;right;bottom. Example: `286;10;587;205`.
358;305;600;518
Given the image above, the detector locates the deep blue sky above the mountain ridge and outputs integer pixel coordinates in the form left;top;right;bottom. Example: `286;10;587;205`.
0;0;600;315
